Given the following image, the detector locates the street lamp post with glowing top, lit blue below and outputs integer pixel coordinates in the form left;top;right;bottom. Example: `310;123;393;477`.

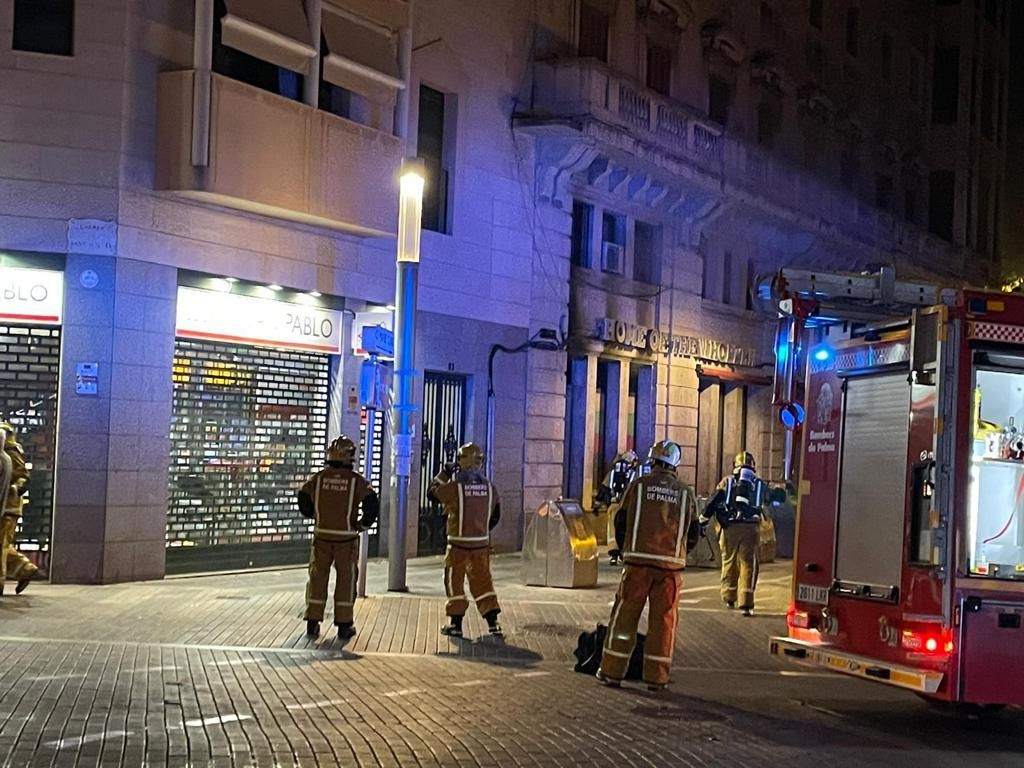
387;160;425;592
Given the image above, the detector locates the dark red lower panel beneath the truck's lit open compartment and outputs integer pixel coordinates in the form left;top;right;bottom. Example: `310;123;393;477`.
959;598;1024;706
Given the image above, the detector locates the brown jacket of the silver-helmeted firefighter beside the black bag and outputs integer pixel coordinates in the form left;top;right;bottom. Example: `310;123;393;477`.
615;467;696;570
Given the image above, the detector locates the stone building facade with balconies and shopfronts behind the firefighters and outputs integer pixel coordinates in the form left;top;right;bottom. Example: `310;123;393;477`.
0;0;1006;582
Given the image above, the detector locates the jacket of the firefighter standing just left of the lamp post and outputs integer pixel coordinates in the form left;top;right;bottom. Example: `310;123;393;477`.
299;466;380;542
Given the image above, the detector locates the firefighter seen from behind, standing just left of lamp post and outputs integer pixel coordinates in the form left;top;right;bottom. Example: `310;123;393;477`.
298;435;380;640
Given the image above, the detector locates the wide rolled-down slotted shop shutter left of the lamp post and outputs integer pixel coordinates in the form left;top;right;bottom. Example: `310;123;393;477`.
167;339;330;573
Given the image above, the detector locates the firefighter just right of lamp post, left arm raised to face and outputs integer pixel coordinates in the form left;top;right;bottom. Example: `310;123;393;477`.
429;442;502;638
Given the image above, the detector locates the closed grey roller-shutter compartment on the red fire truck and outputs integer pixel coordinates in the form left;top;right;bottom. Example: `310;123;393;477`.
835;371;910;599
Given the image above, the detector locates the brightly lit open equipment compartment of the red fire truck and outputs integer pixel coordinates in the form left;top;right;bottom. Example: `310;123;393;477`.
967;364;1024;580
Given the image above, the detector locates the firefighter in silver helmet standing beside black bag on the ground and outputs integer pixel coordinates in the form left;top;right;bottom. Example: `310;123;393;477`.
597;440;696;691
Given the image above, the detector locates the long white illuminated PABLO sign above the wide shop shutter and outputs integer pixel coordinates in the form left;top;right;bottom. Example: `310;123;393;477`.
175;286;341;354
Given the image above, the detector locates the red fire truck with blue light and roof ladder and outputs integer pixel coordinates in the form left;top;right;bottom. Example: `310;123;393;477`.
771;269;1024;707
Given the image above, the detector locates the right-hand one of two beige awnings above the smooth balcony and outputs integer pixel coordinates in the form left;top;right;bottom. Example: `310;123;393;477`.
323;5;406;100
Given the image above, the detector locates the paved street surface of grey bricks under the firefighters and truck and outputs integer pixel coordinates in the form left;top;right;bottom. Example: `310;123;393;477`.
0;556;1024;768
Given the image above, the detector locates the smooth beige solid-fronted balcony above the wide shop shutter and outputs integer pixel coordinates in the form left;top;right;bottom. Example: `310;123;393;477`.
157;71;401;237
